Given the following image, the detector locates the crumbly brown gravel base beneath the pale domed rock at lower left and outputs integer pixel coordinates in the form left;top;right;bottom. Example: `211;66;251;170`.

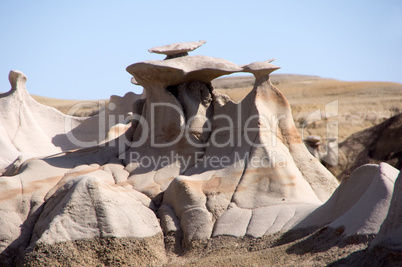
22;235;167;266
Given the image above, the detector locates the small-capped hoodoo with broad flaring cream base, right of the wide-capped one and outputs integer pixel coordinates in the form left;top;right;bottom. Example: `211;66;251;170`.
163;58;338;244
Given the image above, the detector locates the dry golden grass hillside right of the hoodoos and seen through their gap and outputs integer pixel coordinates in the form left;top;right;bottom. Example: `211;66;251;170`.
214;75;402;141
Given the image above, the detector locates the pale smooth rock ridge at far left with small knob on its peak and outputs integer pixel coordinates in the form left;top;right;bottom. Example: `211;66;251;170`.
0;71;141;175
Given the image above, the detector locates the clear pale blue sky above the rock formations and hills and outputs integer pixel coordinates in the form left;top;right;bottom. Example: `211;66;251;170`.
0;0;402;99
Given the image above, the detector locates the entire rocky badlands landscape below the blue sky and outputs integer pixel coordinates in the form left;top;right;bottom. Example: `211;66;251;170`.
0;41;402;266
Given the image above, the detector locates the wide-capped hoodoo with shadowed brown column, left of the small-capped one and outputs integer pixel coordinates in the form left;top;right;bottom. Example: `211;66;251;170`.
125;47;242;201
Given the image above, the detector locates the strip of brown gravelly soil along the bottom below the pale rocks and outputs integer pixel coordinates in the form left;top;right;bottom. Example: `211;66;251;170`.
24;228;372;266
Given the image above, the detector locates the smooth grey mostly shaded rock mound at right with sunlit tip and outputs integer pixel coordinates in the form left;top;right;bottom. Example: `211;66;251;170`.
295;163;399;236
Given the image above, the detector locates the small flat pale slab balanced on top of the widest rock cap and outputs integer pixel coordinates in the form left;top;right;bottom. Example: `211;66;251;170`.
148;40;206;59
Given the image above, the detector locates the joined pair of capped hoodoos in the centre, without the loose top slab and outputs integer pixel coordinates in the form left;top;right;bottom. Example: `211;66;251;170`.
124;50;338;245
